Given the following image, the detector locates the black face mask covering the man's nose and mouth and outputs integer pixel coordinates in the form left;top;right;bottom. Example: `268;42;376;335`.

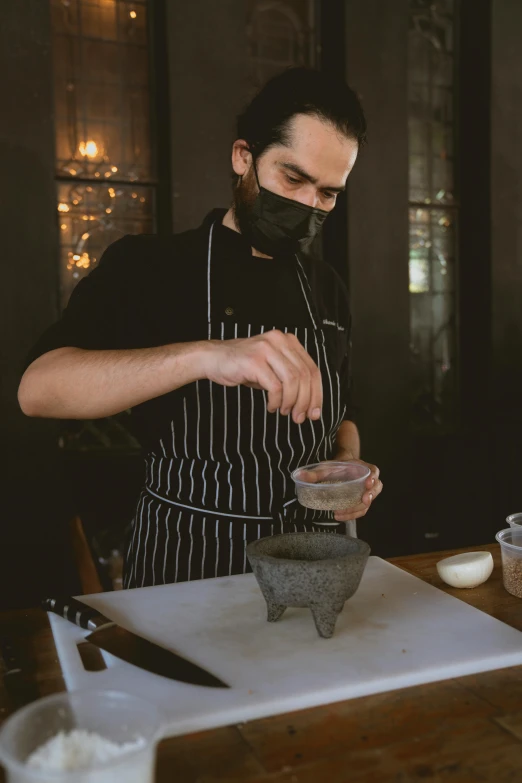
238;157;329;256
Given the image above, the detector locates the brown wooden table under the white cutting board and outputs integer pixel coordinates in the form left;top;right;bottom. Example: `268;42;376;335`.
0;546;522;783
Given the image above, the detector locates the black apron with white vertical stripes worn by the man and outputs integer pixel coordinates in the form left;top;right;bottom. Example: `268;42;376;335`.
123;220;346;588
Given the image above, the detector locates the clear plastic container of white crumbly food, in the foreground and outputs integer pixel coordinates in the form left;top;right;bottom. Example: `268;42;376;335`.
0;691;162;783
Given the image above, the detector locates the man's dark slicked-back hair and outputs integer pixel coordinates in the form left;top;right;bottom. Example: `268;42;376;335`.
237;68;366;157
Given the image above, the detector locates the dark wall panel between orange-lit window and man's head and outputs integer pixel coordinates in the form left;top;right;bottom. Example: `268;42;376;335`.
167;0;247;231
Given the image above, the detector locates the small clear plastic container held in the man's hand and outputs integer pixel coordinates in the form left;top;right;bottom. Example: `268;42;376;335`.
292;460;371;511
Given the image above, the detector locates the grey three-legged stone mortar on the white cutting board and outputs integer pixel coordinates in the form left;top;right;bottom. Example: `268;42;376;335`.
246;533;370;639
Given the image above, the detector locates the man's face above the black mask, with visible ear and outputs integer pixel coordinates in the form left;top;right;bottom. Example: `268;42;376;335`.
232;114;358;230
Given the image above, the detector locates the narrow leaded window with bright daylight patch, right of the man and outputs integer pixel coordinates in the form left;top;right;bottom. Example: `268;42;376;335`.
408;0;458;430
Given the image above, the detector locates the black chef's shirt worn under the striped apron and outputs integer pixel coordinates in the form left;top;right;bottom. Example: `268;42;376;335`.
28;210;353;449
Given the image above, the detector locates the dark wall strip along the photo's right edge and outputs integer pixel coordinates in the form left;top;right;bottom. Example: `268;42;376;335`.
486;0;522;529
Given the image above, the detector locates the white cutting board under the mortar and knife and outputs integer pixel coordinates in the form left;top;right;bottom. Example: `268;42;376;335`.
50;557;522;736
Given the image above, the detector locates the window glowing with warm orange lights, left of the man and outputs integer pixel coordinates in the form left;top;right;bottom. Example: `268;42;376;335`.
51;0;155;306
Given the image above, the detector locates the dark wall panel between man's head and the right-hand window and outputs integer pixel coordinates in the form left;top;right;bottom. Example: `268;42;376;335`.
346;0;410;554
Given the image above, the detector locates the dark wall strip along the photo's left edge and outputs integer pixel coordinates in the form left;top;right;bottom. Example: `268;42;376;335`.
0;0;78;605
